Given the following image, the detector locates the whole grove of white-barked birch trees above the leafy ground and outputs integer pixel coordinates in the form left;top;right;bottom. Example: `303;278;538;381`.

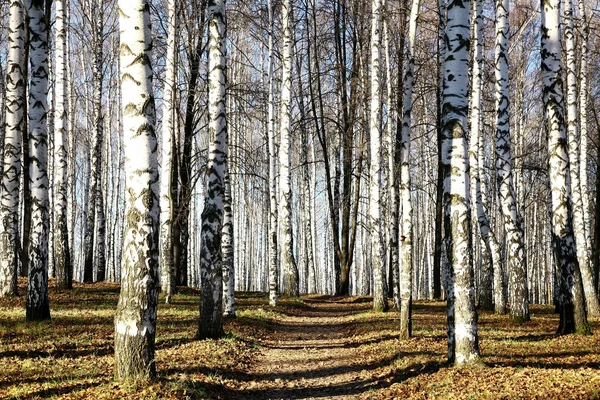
0;0;600;380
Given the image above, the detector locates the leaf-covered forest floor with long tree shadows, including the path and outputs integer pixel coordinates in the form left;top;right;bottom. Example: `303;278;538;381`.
0;280;600;400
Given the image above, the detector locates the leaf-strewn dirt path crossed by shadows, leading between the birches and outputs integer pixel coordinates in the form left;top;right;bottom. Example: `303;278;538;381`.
239;296;392;399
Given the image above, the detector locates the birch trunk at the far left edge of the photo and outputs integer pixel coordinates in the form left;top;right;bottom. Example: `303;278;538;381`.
0;0;26;297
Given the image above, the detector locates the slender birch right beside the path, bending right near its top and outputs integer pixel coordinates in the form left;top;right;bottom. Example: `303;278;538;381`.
400;0;421;339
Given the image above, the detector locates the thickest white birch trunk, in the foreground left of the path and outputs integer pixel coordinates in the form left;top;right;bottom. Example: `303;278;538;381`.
115;0;160;381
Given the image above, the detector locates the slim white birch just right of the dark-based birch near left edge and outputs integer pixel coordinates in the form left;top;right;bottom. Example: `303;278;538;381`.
54;0;73;289
